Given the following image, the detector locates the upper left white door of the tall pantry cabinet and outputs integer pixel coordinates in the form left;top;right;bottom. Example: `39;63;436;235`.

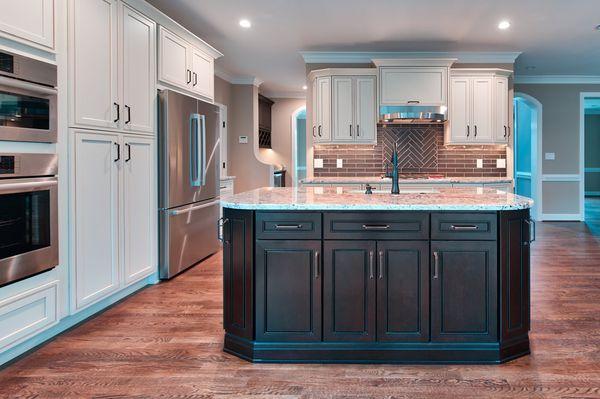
69;0;123;128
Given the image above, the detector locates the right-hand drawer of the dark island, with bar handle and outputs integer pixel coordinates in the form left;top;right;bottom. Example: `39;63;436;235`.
431;213;497;240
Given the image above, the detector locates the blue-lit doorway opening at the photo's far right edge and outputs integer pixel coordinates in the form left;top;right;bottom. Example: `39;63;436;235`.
580;93;600;235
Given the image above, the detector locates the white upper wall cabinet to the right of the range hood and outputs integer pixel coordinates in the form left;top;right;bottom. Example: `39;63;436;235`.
446;69;511;144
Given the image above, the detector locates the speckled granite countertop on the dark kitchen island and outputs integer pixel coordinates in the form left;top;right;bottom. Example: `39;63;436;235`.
221;187;533;211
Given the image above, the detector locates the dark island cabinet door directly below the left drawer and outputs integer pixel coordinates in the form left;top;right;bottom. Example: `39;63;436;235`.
256;240;321;341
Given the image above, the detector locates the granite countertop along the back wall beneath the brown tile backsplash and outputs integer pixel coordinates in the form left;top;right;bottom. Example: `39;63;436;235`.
301;176;513;184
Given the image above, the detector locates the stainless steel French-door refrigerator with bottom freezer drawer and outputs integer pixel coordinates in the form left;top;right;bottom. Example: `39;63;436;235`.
158;90;219;279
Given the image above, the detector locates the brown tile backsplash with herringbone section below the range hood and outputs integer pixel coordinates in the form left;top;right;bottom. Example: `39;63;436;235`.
314;125;506;177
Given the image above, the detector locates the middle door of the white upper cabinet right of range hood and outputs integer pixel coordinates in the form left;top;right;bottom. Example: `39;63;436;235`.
472;78;494;143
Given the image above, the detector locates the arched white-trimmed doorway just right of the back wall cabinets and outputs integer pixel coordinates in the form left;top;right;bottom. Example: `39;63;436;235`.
513;93;542;220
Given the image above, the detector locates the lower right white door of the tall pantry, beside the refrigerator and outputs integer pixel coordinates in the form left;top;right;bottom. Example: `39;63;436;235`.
122;136;158;284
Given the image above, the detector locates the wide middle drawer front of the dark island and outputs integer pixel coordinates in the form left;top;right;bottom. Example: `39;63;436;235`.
323;212;429;240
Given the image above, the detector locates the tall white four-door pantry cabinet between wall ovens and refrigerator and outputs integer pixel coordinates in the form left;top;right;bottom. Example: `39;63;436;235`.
68;0;157;311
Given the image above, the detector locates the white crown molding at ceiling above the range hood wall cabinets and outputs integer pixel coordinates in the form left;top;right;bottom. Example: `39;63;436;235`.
300;51;521;64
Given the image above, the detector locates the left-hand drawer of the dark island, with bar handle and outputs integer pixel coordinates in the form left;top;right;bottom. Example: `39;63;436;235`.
256;212;321;240
